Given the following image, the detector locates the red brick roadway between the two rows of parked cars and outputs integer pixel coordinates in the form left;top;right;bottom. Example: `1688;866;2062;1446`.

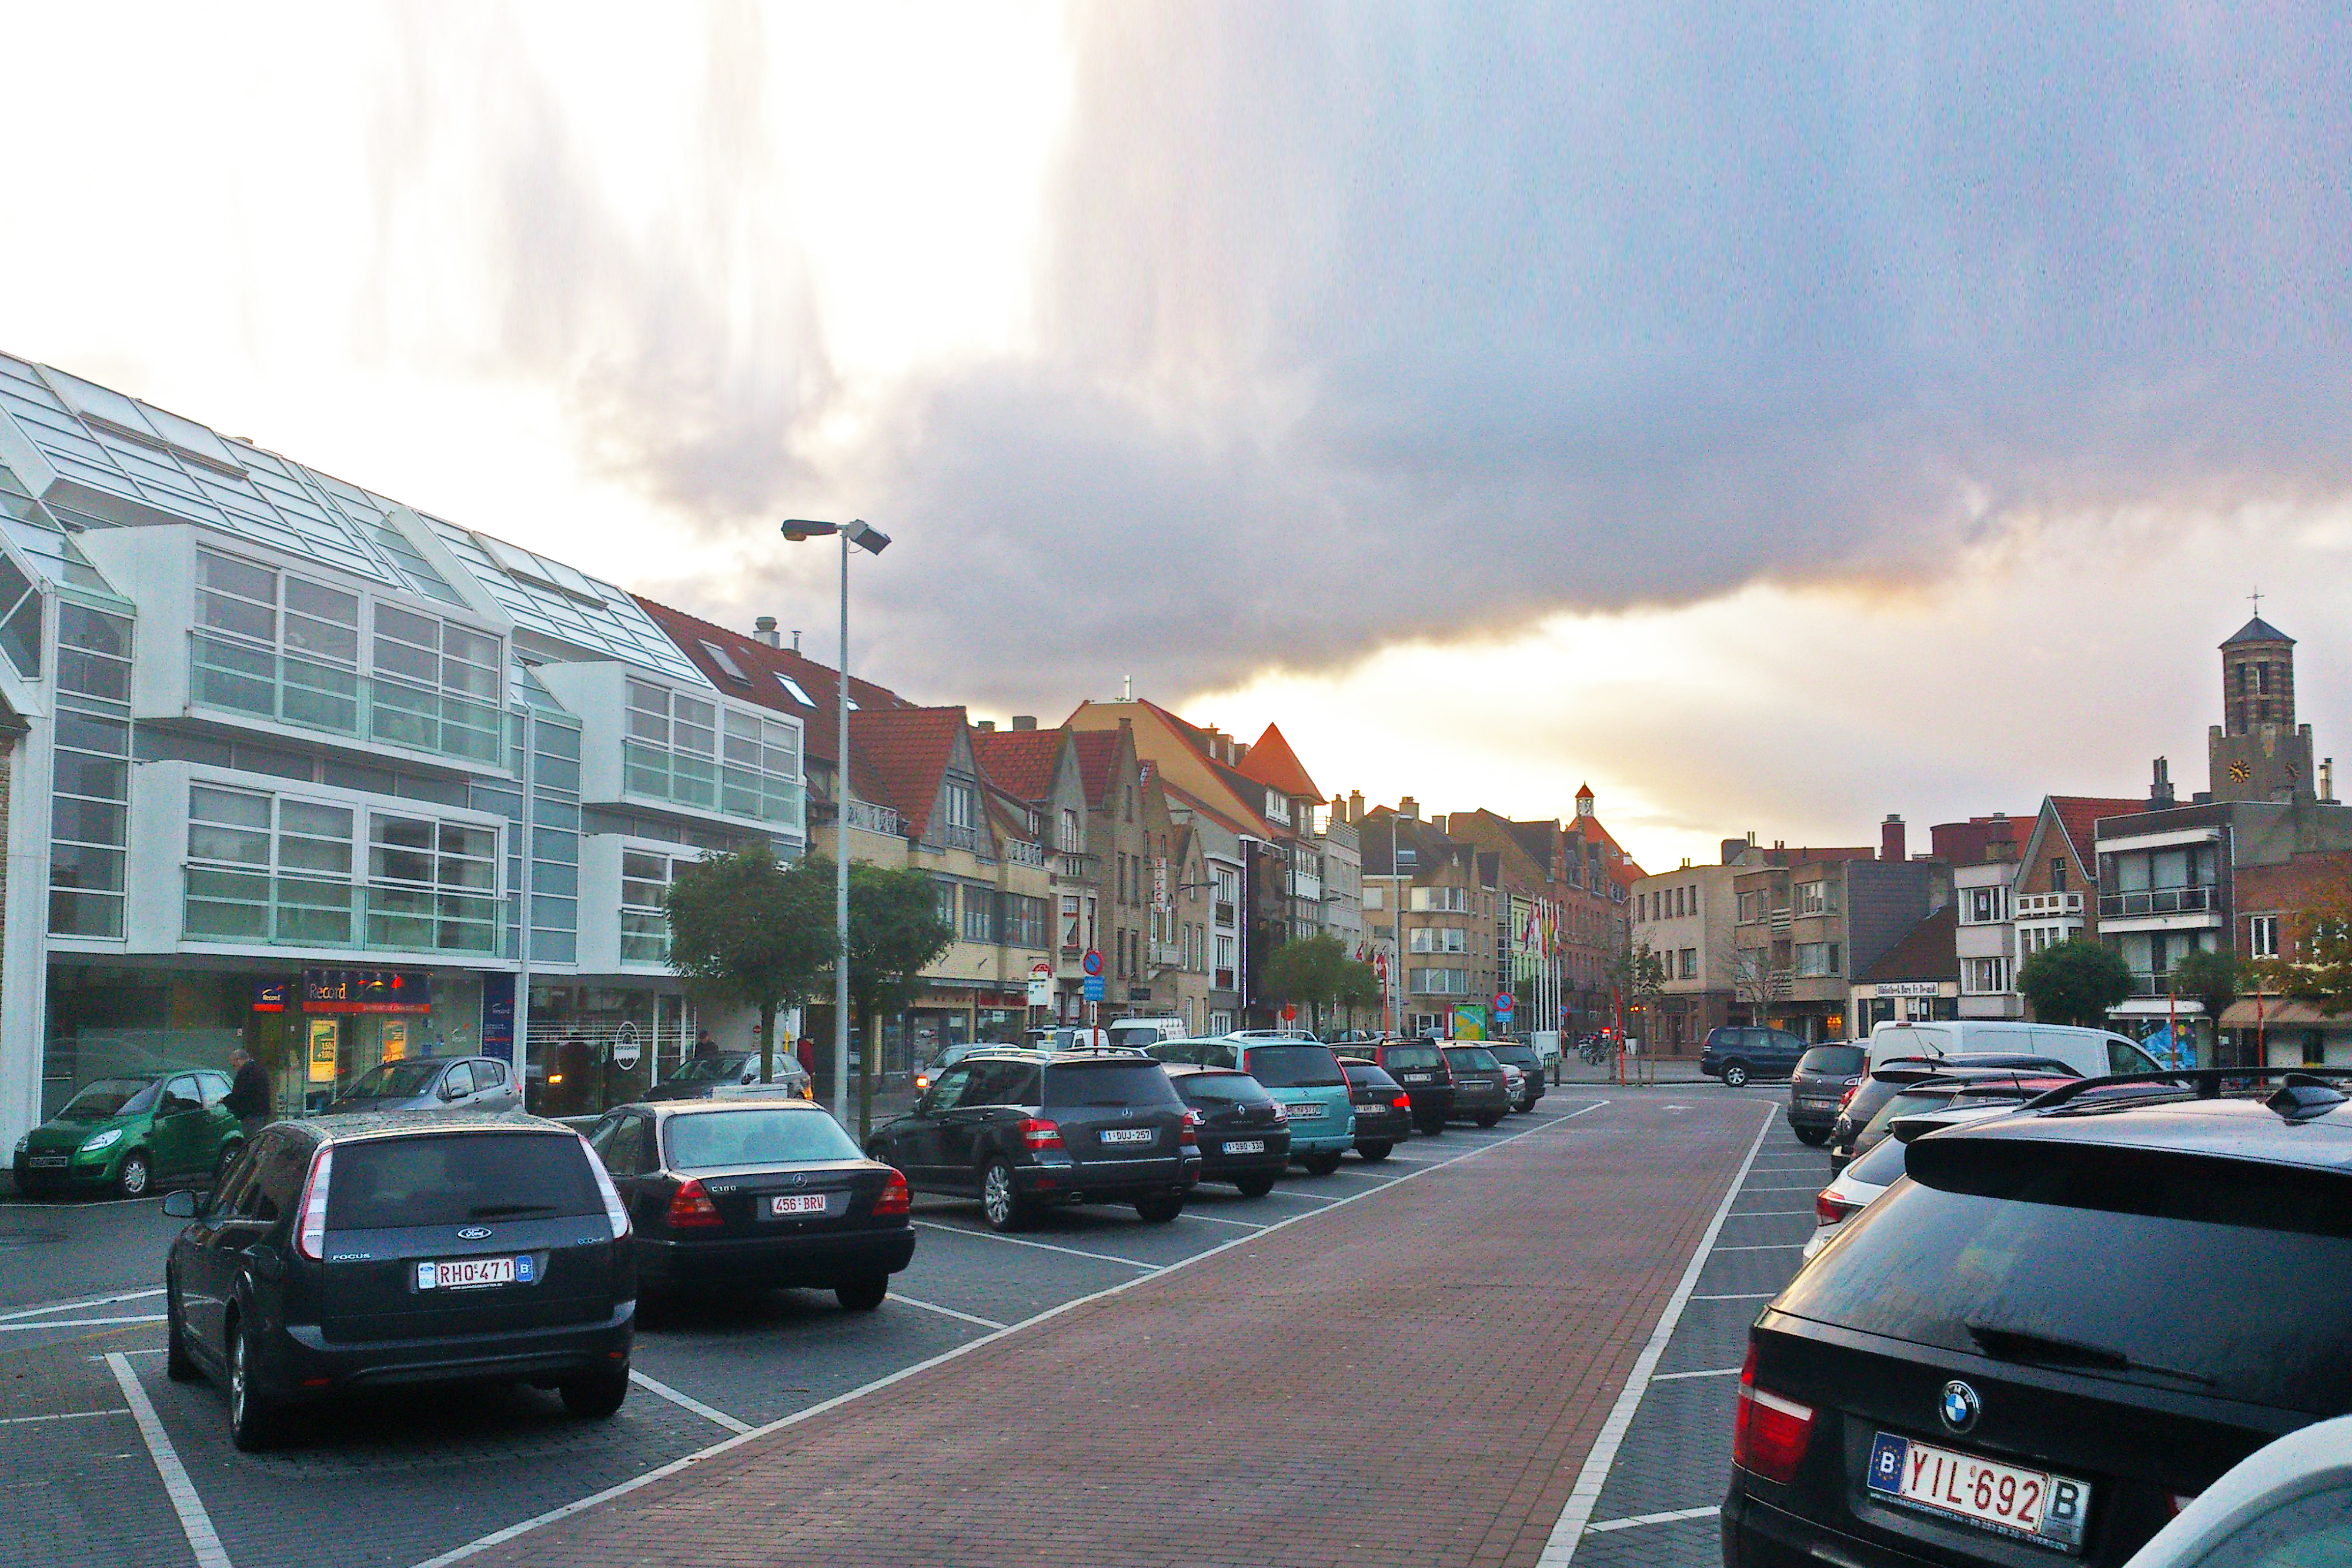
475;1093;1766;1568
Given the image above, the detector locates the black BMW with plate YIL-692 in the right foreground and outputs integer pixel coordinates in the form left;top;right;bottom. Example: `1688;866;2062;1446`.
1722;1067;2352;1568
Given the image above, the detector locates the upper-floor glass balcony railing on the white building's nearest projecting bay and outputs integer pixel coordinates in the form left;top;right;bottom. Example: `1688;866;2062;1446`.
188;633;503;767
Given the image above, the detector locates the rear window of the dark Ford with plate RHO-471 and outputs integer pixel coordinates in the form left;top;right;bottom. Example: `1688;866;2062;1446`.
327;1133;604;1229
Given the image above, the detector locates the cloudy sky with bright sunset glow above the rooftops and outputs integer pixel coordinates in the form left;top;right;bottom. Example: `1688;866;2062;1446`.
0;0;2352;870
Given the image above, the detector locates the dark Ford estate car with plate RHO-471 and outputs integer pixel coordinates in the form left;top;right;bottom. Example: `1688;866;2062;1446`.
165;1112;637;1448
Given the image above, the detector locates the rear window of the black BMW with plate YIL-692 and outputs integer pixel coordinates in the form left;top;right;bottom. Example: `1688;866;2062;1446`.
1778;1140;2352;1415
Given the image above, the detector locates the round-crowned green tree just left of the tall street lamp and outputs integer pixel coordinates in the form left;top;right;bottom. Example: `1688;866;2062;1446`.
663;848;833;1084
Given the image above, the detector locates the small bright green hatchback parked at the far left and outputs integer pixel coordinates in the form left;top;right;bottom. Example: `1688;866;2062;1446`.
14;1069;245;1196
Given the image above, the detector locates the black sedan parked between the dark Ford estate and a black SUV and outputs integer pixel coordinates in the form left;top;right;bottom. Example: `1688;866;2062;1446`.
588;1098;915;1312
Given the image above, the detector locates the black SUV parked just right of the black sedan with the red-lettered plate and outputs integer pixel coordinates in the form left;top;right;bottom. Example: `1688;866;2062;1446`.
866;1048;1200;1229
